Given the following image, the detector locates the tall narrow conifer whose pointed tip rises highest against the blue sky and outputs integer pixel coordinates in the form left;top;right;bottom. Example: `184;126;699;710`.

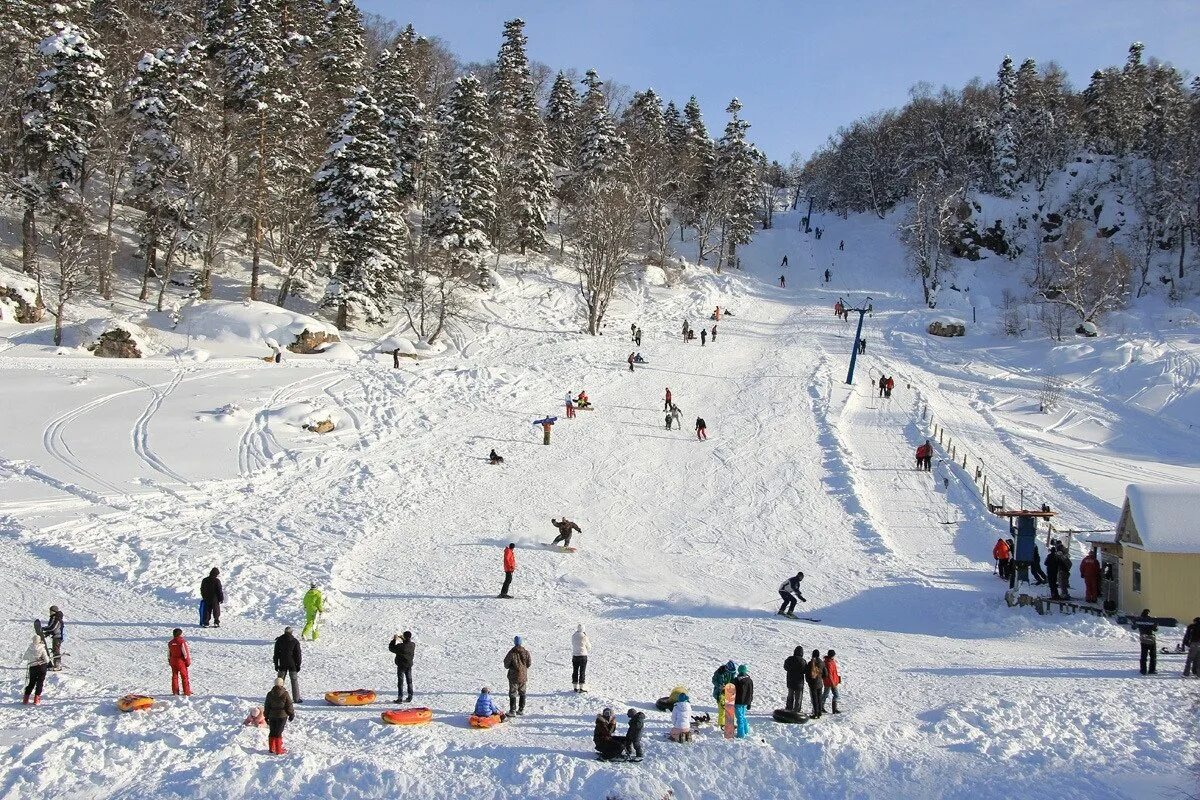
491;19;552;254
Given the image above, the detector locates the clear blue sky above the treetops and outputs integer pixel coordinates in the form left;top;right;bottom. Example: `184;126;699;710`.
359;0;1200;163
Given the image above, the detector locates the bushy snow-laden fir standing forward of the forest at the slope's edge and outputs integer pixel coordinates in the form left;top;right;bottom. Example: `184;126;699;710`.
314;86;408;330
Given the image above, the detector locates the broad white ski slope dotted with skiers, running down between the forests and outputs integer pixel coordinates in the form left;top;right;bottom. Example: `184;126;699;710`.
0;208;1198;800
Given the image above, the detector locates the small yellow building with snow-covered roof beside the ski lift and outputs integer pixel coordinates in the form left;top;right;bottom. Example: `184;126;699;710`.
1091;483;1200;624
